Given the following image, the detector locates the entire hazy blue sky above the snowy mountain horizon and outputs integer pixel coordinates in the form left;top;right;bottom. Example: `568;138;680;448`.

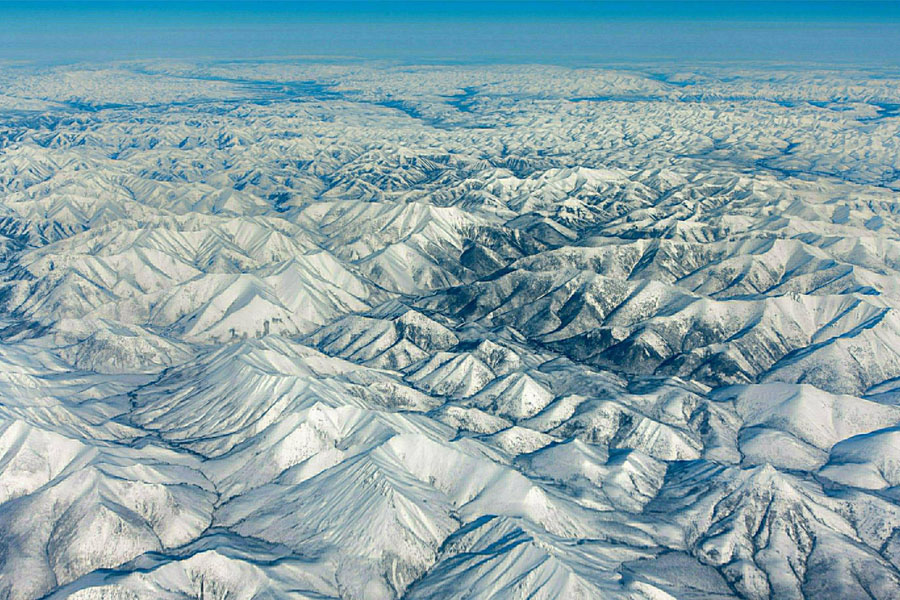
0;0;900;65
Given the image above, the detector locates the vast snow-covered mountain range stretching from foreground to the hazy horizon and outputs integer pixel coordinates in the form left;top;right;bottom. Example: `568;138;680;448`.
0;61;900;600
